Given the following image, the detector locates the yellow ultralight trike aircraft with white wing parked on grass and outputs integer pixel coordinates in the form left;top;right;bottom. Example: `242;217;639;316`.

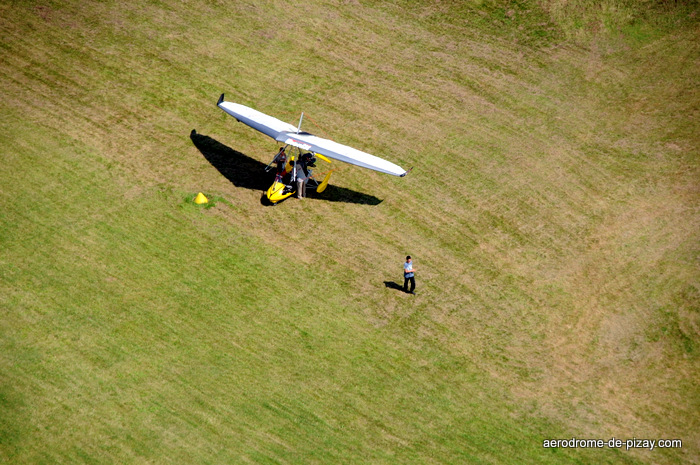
217;94;410;205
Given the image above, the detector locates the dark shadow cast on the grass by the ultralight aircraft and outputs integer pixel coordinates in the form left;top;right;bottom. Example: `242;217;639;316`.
190;129;382;205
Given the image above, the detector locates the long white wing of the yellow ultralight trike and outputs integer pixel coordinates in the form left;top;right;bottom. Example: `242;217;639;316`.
217;94;407;176
